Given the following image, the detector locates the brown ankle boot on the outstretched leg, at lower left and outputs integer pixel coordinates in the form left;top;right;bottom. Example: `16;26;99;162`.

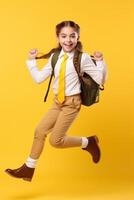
5;164;35;181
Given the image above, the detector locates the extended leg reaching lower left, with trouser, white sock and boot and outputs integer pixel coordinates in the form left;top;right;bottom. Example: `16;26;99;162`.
5;100;60;181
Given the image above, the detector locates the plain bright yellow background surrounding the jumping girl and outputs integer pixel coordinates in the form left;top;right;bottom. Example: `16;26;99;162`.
0;0;134;200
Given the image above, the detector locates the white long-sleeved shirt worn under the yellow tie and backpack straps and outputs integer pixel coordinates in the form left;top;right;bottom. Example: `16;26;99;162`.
26;49;107;96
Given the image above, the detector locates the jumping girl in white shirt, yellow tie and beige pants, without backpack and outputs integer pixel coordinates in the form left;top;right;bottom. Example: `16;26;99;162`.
5;21;106;181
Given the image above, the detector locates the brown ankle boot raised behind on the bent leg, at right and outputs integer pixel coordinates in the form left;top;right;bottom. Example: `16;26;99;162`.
82;135;101;163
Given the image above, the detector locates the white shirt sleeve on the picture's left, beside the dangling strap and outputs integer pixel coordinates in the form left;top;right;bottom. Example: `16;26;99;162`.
26;55;52;83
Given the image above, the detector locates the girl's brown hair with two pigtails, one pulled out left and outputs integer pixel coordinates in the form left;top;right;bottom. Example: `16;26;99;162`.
36;21;82;62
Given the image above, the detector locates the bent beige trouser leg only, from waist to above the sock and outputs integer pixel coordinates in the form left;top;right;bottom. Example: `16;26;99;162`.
50;95;82;148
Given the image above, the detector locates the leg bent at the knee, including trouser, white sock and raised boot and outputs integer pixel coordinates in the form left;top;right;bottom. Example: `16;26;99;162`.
50;95;100;163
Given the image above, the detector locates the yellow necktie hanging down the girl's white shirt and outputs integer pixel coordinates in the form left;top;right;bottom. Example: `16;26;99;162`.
58;53;68;103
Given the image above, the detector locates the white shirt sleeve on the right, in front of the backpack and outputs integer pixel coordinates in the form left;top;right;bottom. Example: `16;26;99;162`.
81;53;107;85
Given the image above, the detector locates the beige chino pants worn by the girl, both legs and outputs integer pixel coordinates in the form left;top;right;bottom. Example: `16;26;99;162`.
30;94;82;159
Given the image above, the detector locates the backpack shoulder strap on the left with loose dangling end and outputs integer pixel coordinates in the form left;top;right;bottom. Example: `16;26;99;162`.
44;50;60;102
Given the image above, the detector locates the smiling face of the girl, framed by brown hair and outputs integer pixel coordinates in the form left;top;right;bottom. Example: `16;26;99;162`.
58;26;79;52
